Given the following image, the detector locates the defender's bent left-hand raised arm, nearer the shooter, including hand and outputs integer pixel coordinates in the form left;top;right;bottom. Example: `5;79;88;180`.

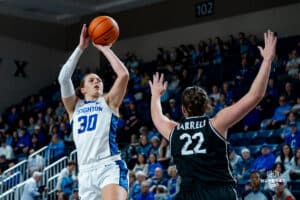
149;72;177;140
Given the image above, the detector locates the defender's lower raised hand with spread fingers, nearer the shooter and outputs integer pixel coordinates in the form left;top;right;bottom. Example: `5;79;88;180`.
149;72;168;96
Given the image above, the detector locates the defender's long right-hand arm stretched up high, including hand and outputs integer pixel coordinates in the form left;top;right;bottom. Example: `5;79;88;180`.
211;30;277;138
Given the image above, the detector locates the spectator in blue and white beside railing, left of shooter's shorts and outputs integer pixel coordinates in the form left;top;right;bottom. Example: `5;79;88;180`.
56;160;77;196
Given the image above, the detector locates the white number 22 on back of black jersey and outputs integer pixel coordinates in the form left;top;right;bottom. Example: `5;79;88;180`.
179;132;206;156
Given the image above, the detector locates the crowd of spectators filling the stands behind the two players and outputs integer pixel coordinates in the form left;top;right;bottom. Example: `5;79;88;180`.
0;32;300;200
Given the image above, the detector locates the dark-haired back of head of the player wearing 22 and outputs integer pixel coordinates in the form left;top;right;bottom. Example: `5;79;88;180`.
182;86;208;116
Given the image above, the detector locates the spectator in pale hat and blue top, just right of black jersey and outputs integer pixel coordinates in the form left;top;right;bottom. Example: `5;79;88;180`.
234;148;253;183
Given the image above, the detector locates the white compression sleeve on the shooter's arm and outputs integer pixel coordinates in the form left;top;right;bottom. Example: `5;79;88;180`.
58;47;83;98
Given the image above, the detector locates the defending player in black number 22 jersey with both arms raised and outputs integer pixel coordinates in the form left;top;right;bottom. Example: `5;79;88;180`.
149;31;277;200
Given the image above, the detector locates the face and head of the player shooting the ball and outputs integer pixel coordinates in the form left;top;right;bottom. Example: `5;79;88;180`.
81;74;103;98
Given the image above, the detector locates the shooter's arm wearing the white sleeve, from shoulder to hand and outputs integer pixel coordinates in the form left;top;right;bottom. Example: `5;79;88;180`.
58;24;89;118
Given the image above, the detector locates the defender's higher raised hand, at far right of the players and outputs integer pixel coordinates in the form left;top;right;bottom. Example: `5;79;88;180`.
258;30;277;61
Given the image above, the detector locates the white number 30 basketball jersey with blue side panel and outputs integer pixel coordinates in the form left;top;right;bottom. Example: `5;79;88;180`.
71;97;120;165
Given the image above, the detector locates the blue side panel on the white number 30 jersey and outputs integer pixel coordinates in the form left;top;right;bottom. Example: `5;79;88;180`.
109;115;120;156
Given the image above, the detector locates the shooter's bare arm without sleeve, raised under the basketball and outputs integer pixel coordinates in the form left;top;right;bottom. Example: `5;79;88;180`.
94;44;129;113
